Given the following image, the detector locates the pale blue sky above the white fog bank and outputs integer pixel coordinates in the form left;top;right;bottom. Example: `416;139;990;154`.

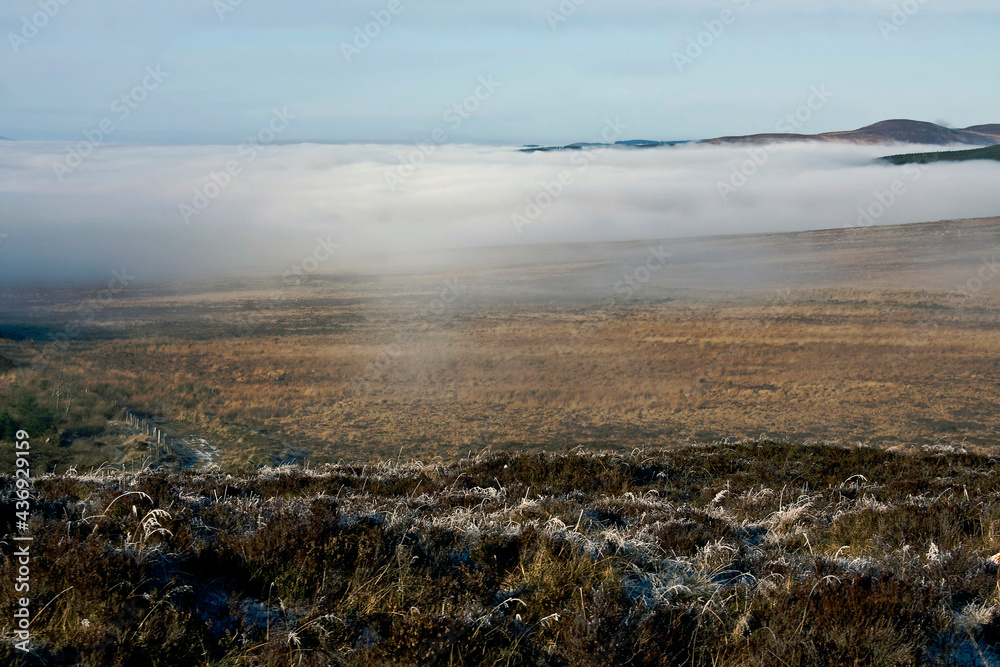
0;0;1000;144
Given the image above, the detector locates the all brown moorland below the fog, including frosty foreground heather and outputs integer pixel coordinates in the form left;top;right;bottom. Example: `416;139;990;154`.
0;219;1000;667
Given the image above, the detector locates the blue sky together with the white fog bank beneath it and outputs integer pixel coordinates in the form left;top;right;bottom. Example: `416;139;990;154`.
0;0;1000;286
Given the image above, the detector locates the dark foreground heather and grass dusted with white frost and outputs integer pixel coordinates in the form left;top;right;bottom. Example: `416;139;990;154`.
0;441;1000;665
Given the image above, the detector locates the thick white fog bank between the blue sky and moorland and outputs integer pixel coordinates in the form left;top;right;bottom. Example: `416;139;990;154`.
0;142;1000;282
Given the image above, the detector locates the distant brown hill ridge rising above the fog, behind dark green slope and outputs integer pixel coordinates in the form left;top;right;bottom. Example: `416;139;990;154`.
521;119;1000;153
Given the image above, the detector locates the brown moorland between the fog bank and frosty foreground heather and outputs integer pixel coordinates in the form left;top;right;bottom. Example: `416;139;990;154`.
0;220;1000;471
